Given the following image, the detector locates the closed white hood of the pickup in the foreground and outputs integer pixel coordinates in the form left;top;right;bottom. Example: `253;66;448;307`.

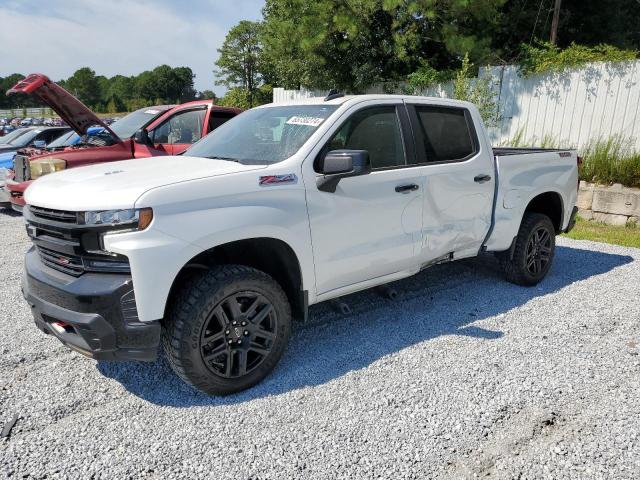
25;155;265;211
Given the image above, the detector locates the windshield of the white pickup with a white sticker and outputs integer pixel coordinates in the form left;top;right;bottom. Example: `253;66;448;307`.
184;105;338;164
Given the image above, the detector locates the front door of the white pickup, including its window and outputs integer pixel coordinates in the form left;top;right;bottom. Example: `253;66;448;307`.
304;101;424;295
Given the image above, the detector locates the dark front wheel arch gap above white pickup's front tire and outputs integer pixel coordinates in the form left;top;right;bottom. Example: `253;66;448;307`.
165;237;308;320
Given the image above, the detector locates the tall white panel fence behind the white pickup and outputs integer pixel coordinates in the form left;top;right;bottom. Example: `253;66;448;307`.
273;61;640;149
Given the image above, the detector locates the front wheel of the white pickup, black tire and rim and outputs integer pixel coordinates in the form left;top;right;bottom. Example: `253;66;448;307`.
162;265;291;395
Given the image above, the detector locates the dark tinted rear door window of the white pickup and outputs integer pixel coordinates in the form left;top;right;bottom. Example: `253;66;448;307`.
415;105;478;163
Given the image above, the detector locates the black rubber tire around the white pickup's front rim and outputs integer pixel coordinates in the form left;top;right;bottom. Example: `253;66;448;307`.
162;265;291;395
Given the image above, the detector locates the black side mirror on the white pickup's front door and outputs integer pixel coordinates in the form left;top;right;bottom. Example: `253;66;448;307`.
317;150;371;193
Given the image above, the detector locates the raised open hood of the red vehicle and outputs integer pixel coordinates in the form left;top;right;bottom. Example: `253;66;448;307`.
7;73;120;141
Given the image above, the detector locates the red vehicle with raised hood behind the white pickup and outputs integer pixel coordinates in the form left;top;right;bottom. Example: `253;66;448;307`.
5;74;240;210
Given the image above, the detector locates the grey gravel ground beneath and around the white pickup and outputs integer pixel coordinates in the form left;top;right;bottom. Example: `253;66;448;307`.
0;214;640;479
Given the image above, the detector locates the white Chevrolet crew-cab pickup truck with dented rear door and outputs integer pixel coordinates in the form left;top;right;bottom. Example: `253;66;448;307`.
23;95;579;394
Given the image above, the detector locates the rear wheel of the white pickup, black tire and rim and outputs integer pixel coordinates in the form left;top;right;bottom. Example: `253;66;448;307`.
501;213;556;287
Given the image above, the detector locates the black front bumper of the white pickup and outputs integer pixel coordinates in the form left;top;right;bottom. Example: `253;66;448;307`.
22;247;160;361
